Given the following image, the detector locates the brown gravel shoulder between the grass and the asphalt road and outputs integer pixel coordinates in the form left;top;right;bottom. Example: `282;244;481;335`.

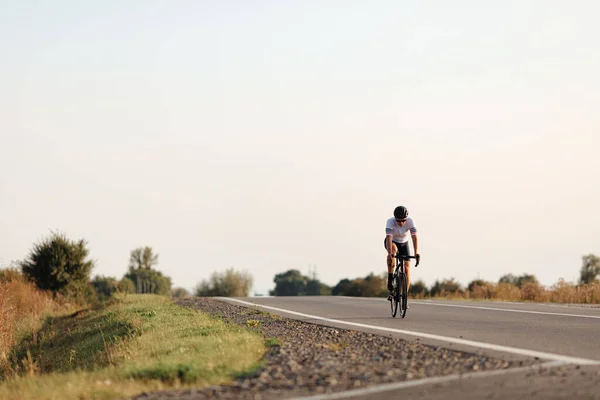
129;297;541;400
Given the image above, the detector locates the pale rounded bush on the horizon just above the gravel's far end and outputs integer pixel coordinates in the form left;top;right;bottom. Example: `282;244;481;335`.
195;268;253;297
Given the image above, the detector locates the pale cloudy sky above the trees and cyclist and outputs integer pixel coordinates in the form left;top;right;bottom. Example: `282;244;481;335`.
0;0;600;294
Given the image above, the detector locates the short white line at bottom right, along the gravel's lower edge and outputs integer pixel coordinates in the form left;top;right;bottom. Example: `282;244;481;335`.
292;361;566;400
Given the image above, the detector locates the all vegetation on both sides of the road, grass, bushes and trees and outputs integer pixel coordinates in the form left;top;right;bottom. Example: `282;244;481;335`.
0;228;600;400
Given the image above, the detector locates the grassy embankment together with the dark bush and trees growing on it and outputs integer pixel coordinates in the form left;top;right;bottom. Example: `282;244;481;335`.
0;233;267;400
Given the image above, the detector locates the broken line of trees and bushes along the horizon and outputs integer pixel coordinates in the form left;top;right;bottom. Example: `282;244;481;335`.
0;232;600;302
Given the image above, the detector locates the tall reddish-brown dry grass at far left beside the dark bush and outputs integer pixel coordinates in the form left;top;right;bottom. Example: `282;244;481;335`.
0;269;56;378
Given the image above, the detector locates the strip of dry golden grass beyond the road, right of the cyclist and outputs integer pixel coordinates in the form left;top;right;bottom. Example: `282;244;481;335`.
435;279;600;304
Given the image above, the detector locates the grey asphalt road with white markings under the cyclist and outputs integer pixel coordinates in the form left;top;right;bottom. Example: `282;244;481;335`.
223;296;600;399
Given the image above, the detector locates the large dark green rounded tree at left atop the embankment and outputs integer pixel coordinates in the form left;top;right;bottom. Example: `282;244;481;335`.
21;232;94;299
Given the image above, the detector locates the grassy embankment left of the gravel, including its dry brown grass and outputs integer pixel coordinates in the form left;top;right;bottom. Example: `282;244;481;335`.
0;270;266;400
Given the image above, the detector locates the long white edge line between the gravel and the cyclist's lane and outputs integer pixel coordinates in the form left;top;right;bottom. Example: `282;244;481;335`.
219;297;600;365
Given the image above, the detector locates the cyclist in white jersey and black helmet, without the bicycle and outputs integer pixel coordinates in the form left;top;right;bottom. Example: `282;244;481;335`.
383;206;421;292
